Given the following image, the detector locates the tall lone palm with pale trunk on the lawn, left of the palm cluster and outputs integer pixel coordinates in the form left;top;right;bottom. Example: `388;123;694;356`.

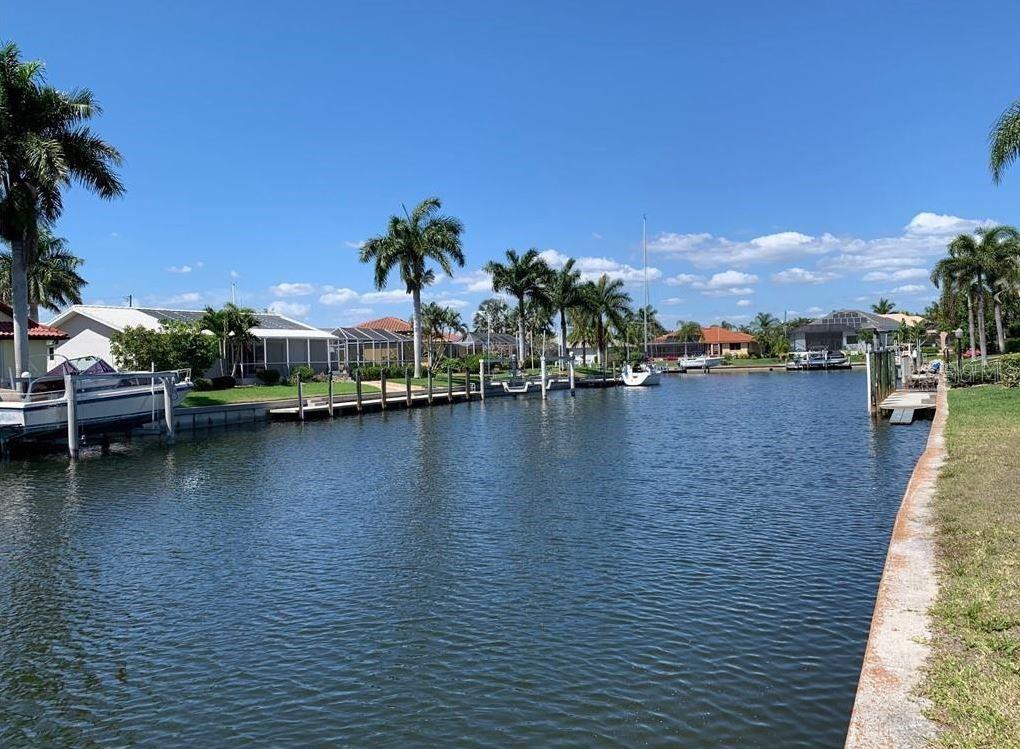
360;198;464;378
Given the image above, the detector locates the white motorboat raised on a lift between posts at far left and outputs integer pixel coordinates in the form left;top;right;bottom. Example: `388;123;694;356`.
0;371;192;441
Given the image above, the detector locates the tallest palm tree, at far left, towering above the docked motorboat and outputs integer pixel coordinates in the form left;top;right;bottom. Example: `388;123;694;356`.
0;44;123;381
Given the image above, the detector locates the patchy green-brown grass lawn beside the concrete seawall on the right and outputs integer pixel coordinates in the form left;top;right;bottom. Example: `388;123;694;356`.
923;386;1020;748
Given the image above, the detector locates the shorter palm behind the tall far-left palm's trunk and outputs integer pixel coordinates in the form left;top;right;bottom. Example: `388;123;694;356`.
0;226;88;320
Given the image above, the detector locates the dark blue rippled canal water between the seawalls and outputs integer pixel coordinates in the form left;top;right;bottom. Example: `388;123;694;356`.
0;372;928;747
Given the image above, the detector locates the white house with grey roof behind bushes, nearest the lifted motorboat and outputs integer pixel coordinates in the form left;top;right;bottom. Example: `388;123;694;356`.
46;304;336;379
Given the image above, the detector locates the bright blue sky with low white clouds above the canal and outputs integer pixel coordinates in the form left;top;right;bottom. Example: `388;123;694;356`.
0;2;1020;326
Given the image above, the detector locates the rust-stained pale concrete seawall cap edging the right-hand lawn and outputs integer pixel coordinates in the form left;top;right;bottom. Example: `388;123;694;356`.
846;381;949;749
